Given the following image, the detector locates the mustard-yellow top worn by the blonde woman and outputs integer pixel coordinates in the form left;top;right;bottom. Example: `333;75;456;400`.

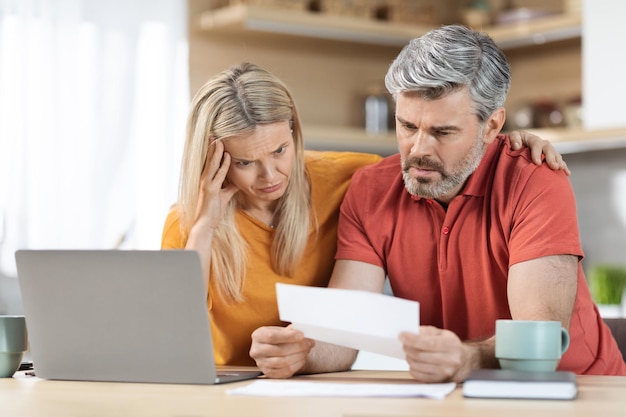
161;151;381;365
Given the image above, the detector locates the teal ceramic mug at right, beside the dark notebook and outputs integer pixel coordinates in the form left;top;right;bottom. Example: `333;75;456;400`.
496;320;569;371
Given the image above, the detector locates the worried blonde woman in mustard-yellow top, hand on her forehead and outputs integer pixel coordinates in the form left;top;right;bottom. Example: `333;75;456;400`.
162;63;567;365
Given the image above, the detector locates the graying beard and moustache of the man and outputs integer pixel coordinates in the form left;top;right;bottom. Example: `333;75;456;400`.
401;133;485;199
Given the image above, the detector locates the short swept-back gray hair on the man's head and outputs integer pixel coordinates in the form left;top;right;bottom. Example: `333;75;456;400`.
385;25;511;122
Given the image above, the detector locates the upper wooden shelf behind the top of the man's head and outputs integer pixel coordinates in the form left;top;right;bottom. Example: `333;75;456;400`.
199;5;582;49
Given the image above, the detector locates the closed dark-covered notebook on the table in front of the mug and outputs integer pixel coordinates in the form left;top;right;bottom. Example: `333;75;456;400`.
463;369;578;400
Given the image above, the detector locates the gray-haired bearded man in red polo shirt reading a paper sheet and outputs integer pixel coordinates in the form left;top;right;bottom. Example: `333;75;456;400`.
251;26;626;382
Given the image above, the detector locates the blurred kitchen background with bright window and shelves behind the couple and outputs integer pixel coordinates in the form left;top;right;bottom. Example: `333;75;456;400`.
0;0;626;313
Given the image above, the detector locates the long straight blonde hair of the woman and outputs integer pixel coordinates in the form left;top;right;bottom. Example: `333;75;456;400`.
178;63;311;302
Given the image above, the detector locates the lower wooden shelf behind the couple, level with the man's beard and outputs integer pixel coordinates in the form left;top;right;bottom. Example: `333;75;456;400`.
304;126;626;156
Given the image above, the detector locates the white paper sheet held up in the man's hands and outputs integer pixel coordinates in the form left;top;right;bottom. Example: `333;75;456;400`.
276;283;419;359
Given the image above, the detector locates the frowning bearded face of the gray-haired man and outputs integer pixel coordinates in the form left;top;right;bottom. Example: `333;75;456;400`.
396;89;487;204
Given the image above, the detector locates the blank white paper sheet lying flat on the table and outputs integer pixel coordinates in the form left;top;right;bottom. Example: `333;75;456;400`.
226;380;456;399
